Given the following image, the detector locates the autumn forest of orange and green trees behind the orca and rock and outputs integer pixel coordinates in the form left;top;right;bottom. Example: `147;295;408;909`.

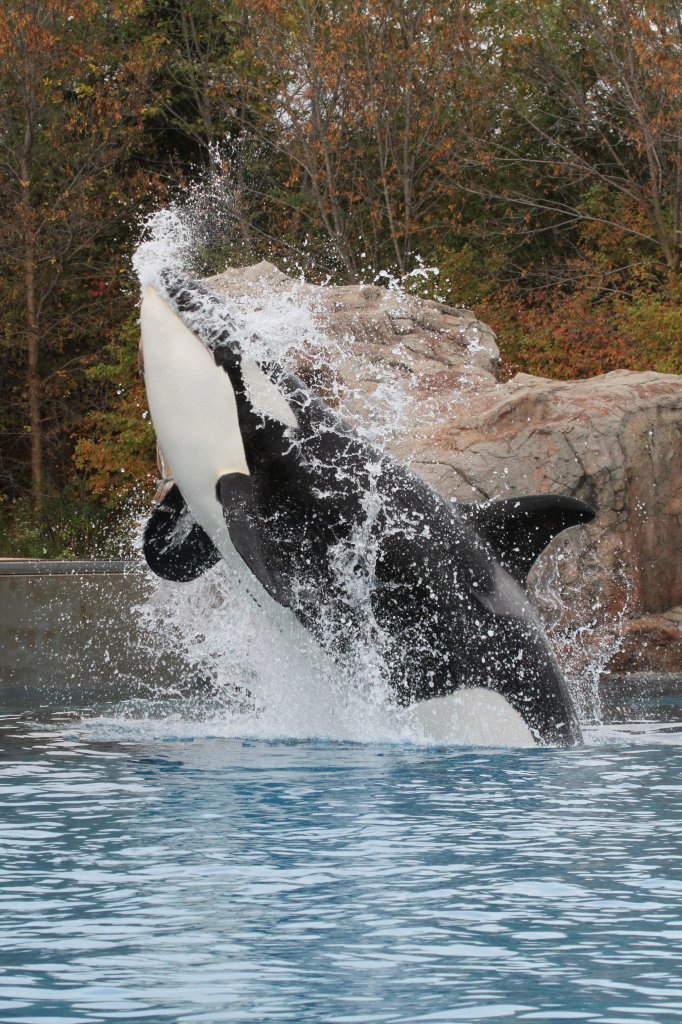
0;0;682;557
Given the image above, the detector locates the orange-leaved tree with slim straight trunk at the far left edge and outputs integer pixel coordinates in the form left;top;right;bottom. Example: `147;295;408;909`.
0;0;155;515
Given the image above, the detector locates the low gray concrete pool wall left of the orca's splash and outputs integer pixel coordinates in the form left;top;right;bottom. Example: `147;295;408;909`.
0;559;182;705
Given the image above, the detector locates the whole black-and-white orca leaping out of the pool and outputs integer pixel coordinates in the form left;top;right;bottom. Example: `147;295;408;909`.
140;272;595;746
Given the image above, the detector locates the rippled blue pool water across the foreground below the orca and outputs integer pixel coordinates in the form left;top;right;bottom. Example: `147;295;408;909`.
0;697;682;1024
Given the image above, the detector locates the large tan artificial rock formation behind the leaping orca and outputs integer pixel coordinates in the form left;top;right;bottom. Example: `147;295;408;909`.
207;263;682;672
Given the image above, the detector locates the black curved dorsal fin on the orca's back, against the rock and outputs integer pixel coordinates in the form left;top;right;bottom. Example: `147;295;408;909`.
464;495;596;586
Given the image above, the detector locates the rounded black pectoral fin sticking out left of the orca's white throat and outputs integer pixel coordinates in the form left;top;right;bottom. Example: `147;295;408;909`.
142;484;220;583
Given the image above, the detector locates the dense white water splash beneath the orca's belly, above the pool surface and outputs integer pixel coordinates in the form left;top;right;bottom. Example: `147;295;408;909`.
131;561;404;740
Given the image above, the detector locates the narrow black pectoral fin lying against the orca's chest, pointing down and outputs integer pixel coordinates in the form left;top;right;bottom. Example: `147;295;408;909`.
216;473;292;607
